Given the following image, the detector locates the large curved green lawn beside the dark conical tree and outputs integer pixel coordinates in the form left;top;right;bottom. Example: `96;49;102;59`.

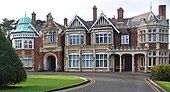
0;75;84;92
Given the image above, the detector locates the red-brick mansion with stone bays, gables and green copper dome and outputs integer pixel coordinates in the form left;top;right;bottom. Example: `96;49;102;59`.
11;5;170;72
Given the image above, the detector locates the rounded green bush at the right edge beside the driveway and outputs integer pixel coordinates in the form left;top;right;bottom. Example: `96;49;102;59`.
151;65;170;81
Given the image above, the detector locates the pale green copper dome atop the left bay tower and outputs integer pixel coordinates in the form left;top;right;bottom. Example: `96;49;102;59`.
13;16;34;32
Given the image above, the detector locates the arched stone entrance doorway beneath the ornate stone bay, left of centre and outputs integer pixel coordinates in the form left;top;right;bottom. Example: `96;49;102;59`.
44;53;57;71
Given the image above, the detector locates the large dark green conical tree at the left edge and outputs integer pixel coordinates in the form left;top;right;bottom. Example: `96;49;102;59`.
0;29;27;87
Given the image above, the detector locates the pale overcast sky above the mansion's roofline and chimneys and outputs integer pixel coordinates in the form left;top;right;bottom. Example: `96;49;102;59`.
0;0;170;24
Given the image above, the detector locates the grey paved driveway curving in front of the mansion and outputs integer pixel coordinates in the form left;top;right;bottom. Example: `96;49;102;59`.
28;72;154;92
